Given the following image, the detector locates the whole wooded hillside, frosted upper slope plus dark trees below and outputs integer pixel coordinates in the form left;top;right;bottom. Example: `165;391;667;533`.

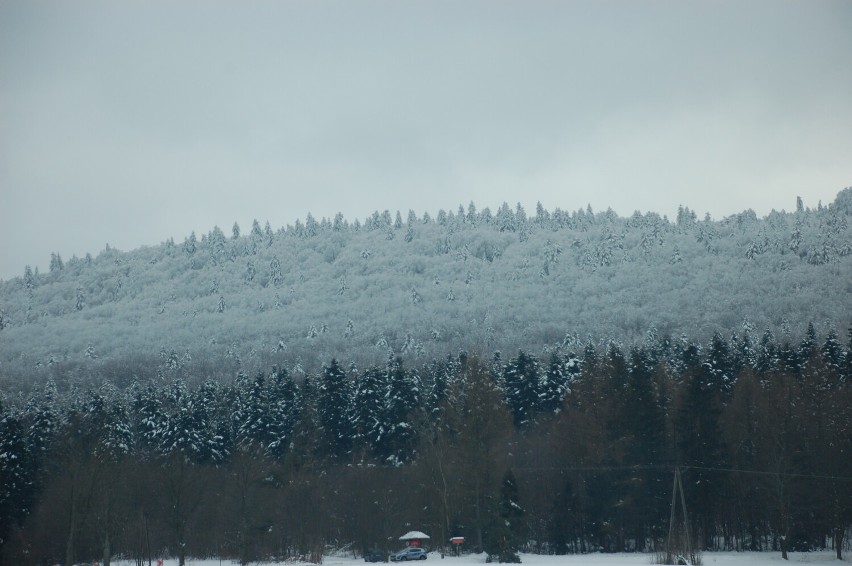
0;189;852;564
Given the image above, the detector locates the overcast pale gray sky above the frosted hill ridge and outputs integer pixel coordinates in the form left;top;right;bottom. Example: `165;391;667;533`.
0;0;852;279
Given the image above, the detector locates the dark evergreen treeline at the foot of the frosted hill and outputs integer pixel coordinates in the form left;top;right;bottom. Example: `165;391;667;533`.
0;325;852;564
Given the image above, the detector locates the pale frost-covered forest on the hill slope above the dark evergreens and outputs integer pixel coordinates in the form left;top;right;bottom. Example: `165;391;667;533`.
0;189;852;392
